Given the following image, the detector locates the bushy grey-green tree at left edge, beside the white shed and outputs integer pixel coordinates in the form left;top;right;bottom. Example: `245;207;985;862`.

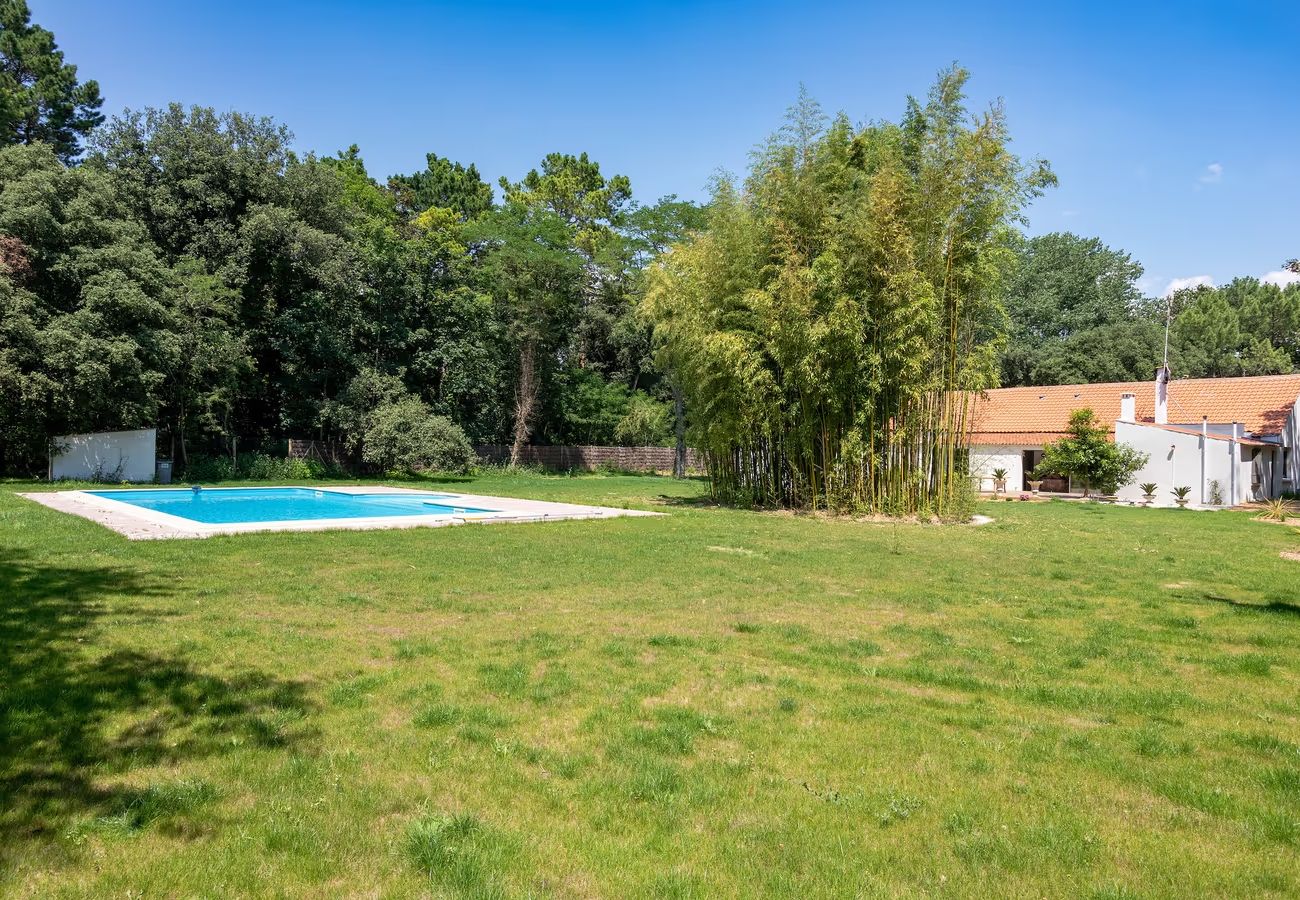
0;144;179;471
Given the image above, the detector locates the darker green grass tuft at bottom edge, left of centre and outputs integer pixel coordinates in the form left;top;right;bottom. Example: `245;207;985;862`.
406;814;517;900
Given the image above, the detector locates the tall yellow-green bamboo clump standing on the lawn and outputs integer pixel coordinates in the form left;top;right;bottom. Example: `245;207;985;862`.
642;68;1054;516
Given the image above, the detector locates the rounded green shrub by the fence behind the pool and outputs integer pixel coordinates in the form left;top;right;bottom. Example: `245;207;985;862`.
361;397;475;472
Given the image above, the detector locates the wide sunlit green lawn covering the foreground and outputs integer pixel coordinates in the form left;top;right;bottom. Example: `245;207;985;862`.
0;475;1300;897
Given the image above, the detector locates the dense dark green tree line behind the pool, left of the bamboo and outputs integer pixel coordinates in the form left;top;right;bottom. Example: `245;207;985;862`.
0;4;701;471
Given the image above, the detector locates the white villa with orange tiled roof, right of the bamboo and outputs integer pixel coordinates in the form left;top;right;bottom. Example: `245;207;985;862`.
969;367;1300;506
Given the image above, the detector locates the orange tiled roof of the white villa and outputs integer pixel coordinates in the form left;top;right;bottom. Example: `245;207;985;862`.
970;375;1300;445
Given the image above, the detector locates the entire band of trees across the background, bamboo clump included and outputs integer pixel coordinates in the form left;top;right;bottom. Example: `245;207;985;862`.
0;0;1300;486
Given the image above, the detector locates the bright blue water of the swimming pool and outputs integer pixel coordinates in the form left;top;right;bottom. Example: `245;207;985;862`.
86;488;495;524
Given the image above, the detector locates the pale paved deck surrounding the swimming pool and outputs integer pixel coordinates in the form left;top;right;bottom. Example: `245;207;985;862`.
18;485;663;541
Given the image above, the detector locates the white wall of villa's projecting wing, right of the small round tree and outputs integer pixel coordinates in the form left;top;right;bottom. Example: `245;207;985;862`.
1115;421;1253;506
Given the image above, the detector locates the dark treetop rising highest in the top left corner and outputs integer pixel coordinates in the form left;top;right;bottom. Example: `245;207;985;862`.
0;0;104;163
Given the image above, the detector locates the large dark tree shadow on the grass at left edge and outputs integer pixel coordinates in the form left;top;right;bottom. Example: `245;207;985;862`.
0;548;309;871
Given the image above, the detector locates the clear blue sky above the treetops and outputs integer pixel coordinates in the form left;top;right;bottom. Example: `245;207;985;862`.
31;0;1300;294
